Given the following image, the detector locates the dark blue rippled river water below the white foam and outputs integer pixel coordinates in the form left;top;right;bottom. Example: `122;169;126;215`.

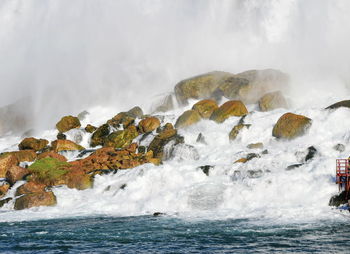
0;216;350;253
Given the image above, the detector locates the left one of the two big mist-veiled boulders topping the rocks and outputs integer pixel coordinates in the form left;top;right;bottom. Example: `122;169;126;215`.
175;71;232;105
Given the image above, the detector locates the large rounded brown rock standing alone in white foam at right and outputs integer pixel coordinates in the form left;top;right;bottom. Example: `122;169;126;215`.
272;113;312;139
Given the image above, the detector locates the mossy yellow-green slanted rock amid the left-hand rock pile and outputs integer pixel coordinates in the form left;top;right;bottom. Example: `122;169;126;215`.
103;125;139;148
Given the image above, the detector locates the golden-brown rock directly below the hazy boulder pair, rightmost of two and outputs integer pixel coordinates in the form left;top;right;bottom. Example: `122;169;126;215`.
210;101;248;123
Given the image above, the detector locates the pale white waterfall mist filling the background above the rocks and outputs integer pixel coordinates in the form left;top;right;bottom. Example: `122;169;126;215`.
0;0;350;131
